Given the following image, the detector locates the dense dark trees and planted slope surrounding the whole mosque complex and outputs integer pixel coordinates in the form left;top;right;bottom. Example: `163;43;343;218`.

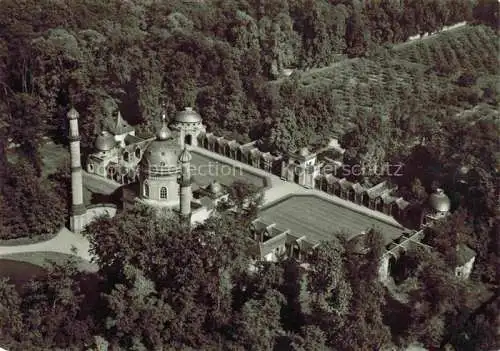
0;0;500;351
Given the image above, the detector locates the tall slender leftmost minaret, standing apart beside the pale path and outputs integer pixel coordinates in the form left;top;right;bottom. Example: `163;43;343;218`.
67;108;87;233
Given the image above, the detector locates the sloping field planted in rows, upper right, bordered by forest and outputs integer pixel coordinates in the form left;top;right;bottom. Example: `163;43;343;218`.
271;25;499;129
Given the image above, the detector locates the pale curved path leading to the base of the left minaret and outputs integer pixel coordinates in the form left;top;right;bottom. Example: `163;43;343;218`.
0;228;92;262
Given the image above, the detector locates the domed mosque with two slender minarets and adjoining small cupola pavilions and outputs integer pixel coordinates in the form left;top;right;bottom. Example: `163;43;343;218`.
68;108;211;232
